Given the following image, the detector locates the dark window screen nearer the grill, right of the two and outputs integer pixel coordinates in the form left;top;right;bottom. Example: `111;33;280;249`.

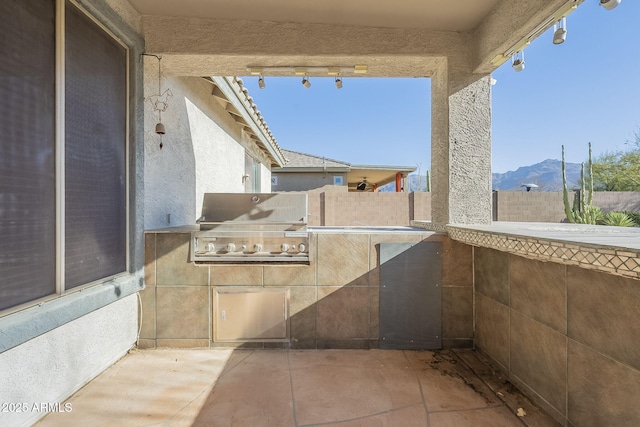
65;2;127;289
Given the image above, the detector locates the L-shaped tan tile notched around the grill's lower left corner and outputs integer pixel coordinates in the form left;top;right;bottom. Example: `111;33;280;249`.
156;233;209;286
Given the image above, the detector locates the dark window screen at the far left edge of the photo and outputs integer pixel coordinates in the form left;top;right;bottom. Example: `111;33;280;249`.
0;0;56;310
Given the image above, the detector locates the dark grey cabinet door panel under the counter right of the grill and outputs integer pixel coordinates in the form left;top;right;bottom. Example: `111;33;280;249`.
380;242;442;350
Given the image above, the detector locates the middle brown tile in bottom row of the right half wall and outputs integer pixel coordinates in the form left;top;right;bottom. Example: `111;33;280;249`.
510;310;567;414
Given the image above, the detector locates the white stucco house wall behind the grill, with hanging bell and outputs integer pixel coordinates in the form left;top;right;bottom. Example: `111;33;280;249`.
144;70;271;229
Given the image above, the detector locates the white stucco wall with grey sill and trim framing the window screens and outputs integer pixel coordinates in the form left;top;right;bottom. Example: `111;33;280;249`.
0;0;144;426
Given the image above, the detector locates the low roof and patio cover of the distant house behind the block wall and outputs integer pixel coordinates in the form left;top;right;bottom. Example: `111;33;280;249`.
271;149;416;189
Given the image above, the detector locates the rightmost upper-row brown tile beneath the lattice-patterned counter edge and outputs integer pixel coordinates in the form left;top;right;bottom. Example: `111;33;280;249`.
567;267;640;369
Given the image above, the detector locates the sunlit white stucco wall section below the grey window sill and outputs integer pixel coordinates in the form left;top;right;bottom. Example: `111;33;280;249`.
0;295;138;426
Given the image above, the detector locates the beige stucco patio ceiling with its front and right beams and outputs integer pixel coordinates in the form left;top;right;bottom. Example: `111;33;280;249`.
129;0;576;82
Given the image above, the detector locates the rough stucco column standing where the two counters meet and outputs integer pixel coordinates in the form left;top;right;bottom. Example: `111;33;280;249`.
431;63;491;225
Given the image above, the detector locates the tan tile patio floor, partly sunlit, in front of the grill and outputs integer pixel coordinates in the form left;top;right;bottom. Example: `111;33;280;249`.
37;349;557;427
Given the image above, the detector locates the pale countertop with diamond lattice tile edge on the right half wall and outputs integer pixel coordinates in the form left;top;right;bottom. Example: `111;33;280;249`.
412;221;640;278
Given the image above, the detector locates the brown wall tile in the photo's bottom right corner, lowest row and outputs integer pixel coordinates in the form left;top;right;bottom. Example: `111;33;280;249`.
568;340;640;427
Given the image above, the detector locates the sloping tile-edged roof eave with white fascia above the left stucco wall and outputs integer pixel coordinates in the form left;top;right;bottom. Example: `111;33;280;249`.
206;77;286;167
